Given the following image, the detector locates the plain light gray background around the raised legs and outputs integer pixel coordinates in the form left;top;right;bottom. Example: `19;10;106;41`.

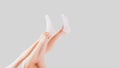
0;0;120;68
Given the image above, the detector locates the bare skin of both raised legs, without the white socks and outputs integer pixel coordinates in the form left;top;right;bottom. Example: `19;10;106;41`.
7;27;65;68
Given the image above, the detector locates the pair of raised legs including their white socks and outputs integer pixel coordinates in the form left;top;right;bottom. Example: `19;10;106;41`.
6;14;71;68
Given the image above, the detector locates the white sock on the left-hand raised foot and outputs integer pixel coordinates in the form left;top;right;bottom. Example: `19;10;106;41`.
45;15;55;35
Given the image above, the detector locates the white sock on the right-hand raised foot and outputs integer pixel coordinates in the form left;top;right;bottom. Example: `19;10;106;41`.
61;14;71;33
